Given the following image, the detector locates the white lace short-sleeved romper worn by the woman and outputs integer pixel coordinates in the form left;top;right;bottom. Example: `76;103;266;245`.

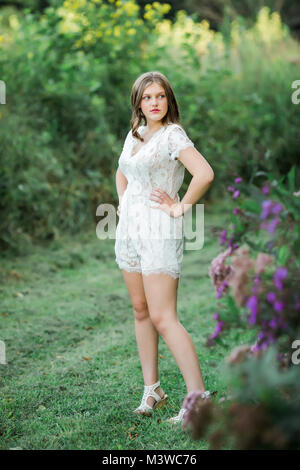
115;123;194;278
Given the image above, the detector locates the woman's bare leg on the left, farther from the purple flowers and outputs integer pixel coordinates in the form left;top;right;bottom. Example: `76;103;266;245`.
122;270;164;406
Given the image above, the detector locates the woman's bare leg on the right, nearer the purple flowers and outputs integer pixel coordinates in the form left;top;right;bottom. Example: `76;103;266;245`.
143;274;205;393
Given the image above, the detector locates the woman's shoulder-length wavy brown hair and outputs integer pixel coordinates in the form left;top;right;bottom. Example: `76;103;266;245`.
130;71;180;142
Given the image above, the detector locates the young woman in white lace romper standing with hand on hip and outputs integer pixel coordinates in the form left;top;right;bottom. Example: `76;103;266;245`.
115;72;214;422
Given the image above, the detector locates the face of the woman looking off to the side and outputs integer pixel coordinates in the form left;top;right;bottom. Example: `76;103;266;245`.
140;83;168;124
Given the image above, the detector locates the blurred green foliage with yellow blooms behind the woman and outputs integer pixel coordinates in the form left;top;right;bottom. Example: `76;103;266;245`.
0;0;300;253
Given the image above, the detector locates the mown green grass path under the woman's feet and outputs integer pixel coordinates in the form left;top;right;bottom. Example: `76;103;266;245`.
0;198;258;450
